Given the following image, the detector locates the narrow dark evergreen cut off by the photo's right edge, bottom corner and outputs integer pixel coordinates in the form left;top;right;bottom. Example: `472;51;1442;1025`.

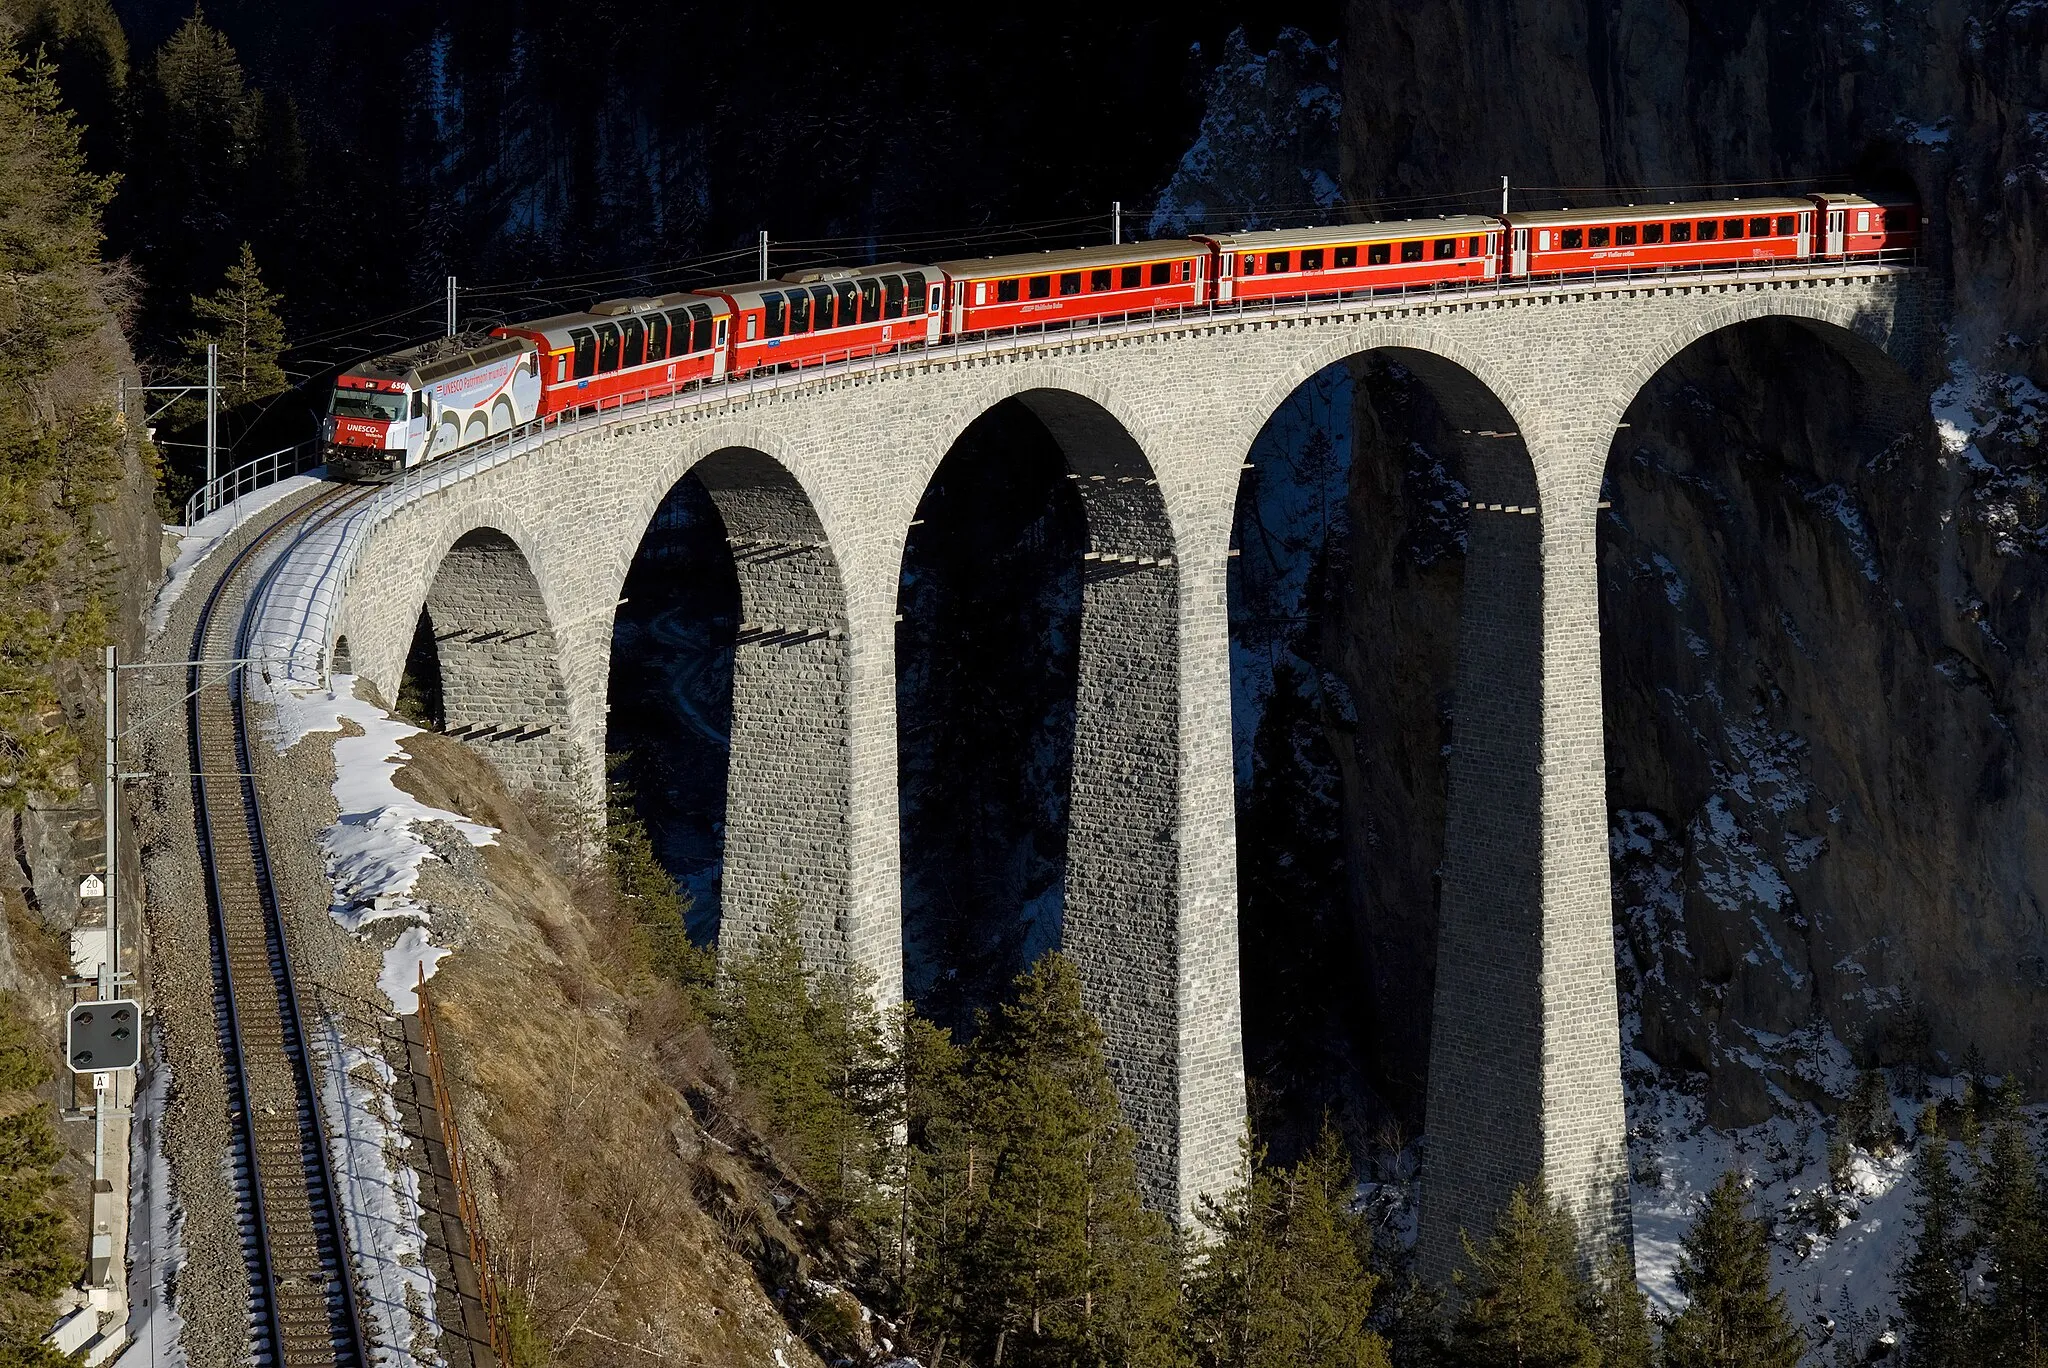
1972;1075;2048;1368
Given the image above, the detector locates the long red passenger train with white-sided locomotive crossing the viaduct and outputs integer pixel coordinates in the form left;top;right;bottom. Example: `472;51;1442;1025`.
324;195;1921;477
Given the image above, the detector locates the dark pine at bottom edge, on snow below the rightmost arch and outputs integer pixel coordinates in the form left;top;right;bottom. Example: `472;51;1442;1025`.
1663;1173;1806;1368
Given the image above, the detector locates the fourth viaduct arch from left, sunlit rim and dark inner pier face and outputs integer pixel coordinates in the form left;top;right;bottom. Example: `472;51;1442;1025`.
1243;335;1581;1278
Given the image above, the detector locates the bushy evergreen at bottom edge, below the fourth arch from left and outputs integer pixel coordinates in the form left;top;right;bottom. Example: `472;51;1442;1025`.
1188;1124;1389;1368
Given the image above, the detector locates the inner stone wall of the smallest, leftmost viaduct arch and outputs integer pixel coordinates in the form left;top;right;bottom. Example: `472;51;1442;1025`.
420;524;590;803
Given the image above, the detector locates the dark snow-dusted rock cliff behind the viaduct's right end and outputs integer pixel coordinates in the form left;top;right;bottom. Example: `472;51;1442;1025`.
1321;0;2048;1124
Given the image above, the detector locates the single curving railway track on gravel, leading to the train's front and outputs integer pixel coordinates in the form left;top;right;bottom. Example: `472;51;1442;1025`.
186;489;371;1368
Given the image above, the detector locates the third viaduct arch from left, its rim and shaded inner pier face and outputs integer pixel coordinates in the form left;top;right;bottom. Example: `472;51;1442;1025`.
905;382;1196;1214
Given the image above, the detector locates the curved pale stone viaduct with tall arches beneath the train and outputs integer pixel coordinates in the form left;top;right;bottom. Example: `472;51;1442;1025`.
258;264;1929;1272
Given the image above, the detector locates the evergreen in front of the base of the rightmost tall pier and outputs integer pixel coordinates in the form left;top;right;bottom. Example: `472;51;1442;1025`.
1450;1182;1599;1368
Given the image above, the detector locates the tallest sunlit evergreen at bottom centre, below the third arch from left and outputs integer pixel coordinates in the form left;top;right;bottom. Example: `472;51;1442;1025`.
922;952;1186;1368
